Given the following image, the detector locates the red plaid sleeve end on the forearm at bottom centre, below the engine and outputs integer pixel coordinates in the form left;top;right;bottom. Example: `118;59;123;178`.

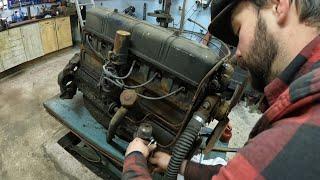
122;151;151;179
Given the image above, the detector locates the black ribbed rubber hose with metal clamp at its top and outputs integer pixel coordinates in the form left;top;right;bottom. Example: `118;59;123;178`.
166;113;204;180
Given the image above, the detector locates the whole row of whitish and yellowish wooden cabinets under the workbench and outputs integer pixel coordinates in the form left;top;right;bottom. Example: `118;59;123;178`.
0;17;72;72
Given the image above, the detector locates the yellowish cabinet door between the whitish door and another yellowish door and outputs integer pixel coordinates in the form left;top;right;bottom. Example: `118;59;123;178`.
39;19;58;54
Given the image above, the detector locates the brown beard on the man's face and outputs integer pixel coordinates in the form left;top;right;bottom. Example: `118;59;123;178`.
239;16;279;92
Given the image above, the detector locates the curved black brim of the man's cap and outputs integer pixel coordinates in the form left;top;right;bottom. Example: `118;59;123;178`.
208;2;239;47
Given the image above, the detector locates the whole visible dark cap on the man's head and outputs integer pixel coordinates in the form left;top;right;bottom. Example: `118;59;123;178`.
208;0;241;46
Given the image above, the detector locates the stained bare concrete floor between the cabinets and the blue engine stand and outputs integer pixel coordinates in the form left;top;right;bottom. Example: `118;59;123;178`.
0;48;99;180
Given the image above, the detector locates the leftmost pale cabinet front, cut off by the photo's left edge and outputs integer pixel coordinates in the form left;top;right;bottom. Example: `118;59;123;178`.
0;28;26;70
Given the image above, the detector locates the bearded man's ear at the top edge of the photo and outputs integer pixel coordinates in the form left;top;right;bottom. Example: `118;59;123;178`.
272;0;290;25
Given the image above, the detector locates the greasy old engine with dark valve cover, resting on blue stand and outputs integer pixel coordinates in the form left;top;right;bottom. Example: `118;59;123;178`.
59;8;231;150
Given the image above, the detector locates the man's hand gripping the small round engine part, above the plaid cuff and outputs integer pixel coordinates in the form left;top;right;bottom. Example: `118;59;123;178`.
125;138;157;158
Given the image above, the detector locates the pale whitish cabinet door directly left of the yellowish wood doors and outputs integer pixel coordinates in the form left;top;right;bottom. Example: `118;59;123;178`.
21;23;43;60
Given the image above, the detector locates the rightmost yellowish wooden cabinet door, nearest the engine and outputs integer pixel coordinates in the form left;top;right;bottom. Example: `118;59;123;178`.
56;17;72;49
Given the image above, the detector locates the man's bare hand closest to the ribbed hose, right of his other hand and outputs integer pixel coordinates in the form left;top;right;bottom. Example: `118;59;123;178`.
149;151;171;172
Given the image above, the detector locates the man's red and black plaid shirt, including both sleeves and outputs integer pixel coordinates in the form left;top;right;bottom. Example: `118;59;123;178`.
123;36;320;180
